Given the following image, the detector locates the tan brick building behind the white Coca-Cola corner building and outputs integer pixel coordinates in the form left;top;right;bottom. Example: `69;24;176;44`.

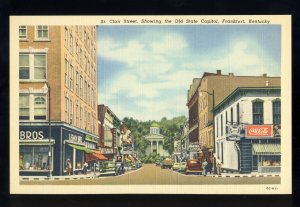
187;70;280;162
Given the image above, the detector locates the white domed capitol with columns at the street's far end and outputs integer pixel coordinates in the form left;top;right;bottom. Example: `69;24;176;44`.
144;122;169;156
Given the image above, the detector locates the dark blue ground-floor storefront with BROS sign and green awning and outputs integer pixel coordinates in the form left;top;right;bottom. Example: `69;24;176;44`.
19;123;98;176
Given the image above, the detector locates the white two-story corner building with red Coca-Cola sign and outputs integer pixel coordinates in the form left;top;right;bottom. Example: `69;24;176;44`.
214;87;281;173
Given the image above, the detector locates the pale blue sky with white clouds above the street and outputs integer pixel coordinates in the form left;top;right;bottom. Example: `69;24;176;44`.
97;25;281;121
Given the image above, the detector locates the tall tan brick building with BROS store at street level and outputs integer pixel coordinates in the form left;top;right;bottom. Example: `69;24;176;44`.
19;25;98;175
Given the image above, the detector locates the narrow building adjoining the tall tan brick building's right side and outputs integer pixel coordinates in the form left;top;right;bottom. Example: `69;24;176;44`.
98;104;121;159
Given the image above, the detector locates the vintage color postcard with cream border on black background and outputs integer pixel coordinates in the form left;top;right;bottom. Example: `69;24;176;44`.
10;15;292;194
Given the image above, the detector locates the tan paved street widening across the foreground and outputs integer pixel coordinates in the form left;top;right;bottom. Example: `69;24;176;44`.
20;164;280;185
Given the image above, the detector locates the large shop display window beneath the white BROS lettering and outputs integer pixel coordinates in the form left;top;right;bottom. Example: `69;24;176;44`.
19;146;49;171
